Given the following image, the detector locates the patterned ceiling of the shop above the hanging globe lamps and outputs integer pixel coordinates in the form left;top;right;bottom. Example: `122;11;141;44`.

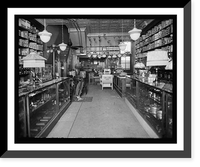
36;18;153;35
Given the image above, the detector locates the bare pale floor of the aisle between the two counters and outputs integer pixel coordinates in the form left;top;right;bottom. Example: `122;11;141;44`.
48;85;149;138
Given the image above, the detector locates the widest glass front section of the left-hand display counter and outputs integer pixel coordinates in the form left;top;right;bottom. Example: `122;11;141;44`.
29;84;58;137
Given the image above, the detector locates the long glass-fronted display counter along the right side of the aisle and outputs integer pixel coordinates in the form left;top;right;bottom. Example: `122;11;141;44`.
126;76;174;138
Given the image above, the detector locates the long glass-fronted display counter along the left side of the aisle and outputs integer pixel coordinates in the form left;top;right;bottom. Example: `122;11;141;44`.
16;77;70;138
